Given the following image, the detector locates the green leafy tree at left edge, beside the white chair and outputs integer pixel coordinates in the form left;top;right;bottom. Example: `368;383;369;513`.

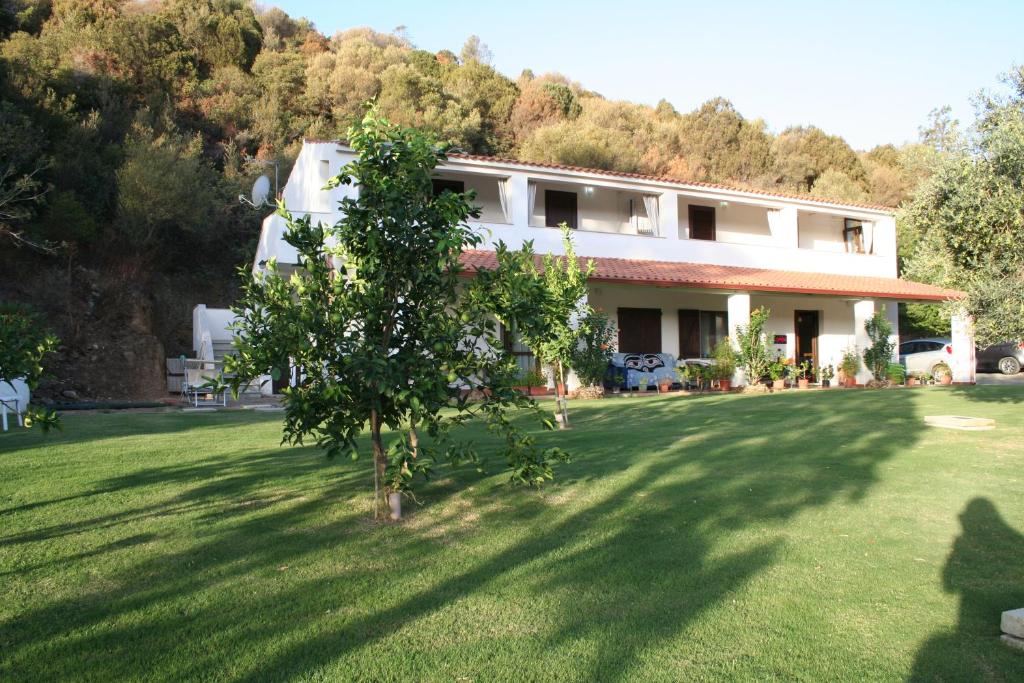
0;303;60;431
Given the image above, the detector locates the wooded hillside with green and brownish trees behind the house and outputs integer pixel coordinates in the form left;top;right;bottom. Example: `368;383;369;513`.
0;0;952;396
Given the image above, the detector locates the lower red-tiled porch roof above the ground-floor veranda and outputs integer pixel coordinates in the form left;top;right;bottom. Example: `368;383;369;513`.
462;250;964;301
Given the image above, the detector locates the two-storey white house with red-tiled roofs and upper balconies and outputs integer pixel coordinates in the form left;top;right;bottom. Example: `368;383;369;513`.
196;140;974;393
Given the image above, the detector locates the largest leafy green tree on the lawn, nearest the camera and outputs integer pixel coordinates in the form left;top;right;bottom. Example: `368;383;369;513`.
227;110;565;514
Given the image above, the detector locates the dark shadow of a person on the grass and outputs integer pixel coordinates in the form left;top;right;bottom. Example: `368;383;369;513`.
909;498;1024;681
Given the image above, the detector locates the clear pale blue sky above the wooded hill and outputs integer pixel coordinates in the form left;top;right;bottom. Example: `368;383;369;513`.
266;0;1024;148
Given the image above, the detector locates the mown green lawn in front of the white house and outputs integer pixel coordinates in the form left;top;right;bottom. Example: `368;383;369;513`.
0;387;1024;681
